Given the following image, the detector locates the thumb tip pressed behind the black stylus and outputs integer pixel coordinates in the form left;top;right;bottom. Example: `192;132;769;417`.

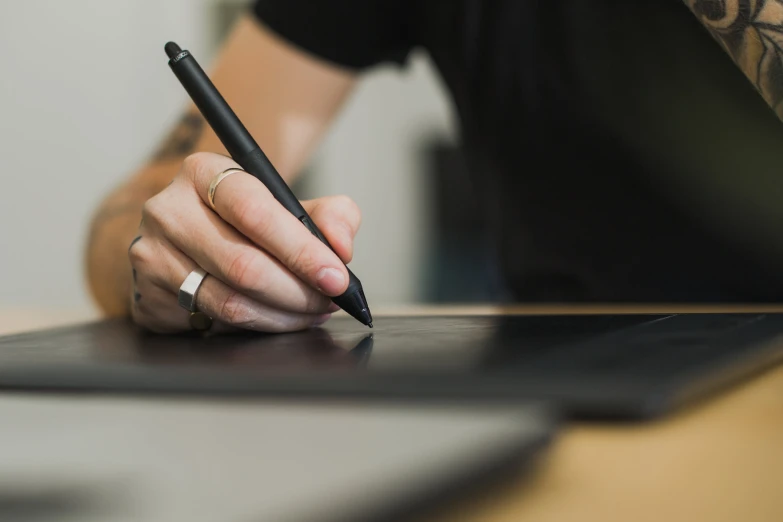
302;196;362;264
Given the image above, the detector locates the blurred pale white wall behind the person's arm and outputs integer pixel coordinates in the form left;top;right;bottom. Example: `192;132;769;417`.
0;0;453;315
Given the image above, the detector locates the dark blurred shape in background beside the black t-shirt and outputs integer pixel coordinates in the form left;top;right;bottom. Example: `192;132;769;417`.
420;138;507;303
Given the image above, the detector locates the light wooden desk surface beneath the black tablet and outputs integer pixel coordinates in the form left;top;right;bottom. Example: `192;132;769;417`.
0;306;783;522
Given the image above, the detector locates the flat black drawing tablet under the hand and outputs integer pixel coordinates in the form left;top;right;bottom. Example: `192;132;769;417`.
0;314;783;417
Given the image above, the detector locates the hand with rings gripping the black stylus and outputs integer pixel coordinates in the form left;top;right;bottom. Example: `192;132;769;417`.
128;153;361;333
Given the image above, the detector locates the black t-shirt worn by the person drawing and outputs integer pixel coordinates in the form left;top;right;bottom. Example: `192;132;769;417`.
254;0;783;302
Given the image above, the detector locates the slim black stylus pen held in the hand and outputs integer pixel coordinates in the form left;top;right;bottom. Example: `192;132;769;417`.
165;42;372;328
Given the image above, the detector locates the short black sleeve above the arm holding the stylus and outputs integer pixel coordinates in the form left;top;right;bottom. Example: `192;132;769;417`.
253;0;416;69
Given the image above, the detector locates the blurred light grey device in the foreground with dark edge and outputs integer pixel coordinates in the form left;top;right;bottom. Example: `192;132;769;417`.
0;386;556;522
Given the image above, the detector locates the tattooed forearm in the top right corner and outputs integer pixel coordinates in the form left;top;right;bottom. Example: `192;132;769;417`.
684;0;783;119
